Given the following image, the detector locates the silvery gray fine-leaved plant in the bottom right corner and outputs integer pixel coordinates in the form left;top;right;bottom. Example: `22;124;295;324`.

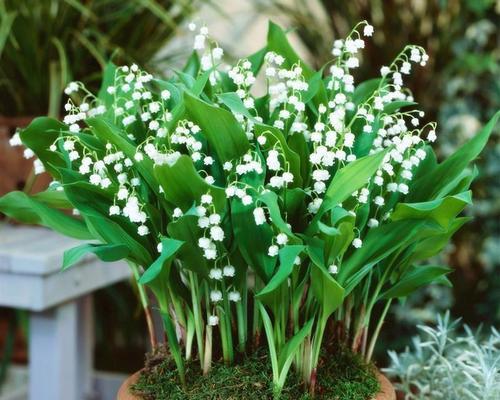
384;312;500;400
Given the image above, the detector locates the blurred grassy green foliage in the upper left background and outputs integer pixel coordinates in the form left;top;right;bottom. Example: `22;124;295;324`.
0;0;203;116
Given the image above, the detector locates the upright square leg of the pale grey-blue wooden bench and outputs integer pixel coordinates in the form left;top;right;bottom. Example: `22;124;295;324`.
29;295;93;400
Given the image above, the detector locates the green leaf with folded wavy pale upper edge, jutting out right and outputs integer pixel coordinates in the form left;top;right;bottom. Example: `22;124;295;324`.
391;191;472;229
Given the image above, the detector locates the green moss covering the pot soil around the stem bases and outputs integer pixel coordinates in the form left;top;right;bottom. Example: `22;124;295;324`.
133;350;379;400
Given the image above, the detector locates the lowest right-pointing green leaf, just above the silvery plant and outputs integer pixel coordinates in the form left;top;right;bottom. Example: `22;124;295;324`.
380;265;452;299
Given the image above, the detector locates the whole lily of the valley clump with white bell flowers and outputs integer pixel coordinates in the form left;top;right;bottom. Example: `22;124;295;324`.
0;22;498;396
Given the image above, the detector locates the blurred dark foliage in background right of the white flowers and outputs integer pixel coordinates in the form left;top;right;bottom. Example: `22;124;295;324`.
255;0;500;332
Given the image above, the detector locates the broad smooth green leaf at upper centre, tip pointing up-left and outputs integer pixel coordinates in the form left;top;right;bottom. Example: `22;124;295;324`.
184;92;250;162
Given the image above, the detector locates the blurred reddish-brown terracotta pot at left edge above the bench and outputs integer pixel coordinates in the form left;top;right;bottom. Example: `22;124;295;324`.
0;116;50;196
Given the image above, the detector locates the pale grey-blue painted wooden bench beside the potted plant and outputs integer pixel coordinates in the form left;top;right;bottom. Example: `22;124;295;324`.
0;224;131;400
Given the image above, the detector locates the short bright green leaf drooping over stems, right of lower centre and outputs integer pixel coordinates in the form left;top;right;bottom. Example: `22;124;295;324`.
311;262;344;319
